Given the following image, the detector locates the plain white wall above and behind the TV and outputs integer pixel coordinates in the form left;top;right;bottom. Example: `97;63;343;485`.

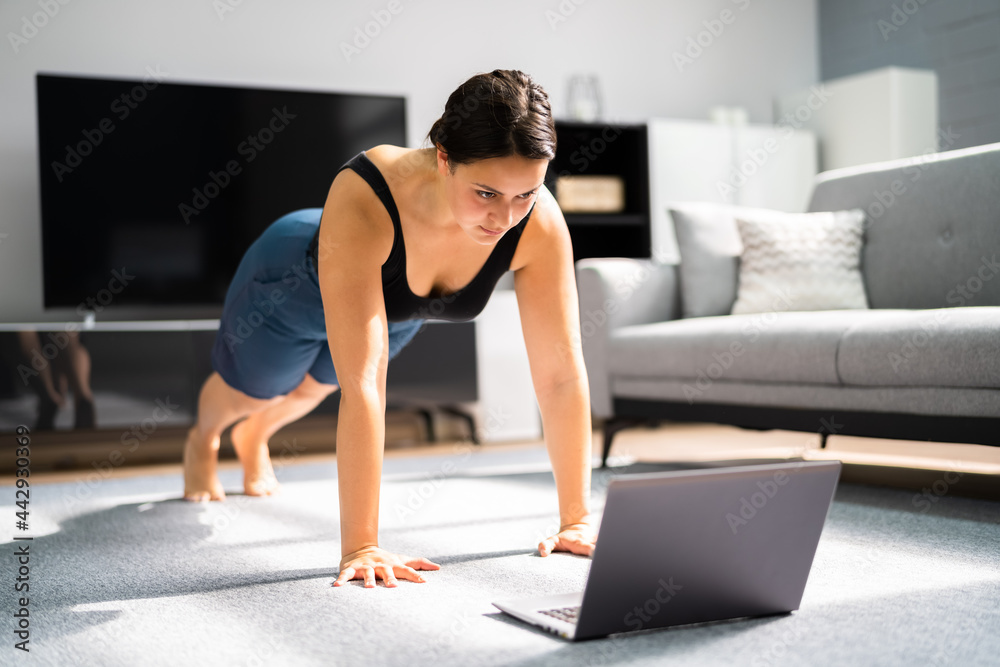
0;0;818;322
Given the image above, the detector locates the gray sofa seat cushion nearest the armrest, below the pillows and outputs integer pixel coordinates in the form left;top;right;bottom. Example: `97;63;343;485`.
608;310;898;385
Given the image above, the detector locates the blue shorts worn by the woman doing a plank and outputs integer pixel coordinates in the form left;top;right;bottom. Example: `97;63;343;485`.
212;208;423;398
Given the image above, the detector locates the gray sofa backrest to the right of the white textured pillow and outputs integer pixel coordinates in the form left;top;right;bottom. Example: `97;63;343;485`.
809;144;1000;309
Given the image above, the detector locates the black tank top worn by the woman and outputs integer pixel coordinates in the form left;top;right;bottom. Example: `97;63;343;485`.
308;151;535;322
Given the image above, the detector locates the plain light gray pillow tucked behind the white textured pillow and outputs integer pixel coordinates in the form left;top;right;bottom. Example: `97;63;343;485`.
668;202;775;317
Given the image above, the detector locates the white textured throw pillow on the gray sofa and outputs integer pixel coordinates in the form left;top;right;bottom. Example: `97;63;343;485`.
732;209;868;315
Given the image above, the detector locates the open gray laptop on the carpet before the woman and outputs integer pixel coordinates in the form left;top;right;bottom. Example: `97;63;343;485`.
493;461;841;640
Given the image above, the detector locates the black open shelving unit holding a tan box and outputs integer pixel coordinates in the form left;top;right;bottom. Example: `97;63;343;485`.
545;120;650;260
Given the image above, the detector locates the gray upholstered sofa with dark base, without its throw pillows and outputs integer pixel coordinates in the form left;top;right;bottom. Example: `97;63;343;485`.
577;144;1000;462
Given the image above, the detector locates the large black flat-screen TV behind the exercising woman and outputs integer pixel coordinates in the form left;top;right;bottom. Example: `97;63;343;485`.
36;73;406;318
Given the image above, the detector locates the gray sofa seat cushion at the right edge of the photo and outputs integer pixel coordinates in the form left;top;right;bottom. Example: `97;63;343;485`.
837;306;1000;388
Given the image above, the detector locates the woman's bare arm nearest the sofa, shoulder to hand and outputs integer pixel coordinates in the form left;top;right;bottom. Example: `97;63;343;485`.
514;187;597;556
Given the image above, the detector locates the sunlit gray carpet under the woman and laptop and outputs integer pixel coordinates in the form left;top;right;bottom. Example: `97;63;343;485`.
0;448;1000;667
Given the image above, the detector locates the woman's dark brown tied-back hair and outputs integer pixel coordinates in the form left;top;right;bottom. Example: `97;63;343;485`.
427;69;556;170
